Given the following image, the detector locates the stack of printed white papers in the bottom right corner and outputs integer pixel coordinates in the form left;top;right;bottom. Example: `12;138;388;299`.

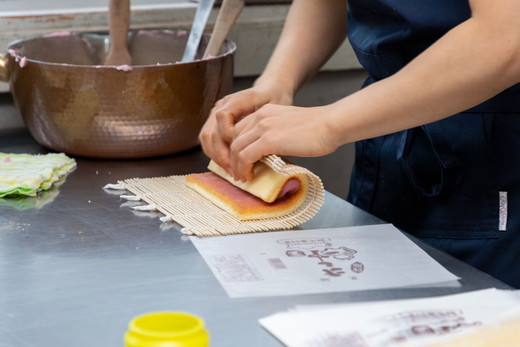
260;288;520;347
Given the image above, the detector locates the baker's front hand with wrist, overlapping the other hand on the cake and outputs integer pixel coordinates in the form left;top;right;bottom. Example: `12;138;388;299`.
229;104;339;180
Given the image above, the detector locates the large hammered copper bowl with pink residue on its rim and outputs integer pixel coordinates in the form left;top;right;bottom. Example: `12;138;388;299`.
0;30;236;158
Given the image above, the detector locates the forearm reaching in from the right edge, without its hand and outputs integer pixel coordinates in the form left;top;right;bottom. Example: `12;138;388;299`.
330;5;520;145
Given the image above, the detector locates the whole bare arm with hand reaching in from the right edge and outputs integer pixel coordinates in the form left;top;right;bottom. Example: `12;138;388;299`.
230;0;520;179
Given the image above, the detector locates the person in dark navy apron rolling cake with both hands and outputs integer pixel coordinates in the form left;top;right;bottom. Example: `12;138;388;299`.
199;0;520;288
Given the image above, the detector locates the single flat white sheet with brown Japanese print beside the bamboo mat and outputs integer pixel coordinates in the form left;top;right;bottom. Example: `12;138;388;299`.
191;224;457;298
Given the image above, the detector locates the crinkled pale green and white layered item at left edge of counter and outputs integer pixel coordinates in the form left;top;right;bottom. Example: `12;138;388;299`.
0;153;76;198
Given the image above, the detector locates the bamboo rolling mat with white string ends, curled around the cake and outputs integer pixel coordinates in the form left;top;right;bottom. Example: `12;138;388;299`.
106;155;324;236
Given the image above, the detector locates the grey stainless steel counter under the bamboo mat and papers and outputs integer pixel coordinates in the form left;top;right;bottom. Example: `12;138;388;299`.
0;130;508;347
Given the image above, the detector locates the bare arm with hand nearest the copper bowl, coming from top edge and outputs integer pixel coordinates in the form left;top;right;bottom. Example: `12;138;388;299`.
199;0;347;174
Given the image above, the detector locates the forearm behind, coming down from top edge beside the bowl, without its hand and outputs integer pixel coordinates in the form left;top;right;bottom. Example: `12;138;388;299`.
255;0;347;97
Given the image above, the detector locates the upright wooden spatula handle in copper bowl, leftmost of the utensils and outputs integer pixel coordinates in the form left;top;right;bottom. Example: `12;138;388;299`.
105;0;132;66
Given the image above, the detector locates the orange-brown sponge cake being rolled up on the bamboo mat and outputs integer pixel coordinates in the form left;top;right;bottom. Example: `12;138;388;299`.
186;161;309;220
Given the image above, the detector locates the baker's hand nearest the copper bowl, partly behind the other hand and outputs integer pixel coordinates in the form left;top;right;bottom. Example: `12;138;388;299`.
199;87;292;175
